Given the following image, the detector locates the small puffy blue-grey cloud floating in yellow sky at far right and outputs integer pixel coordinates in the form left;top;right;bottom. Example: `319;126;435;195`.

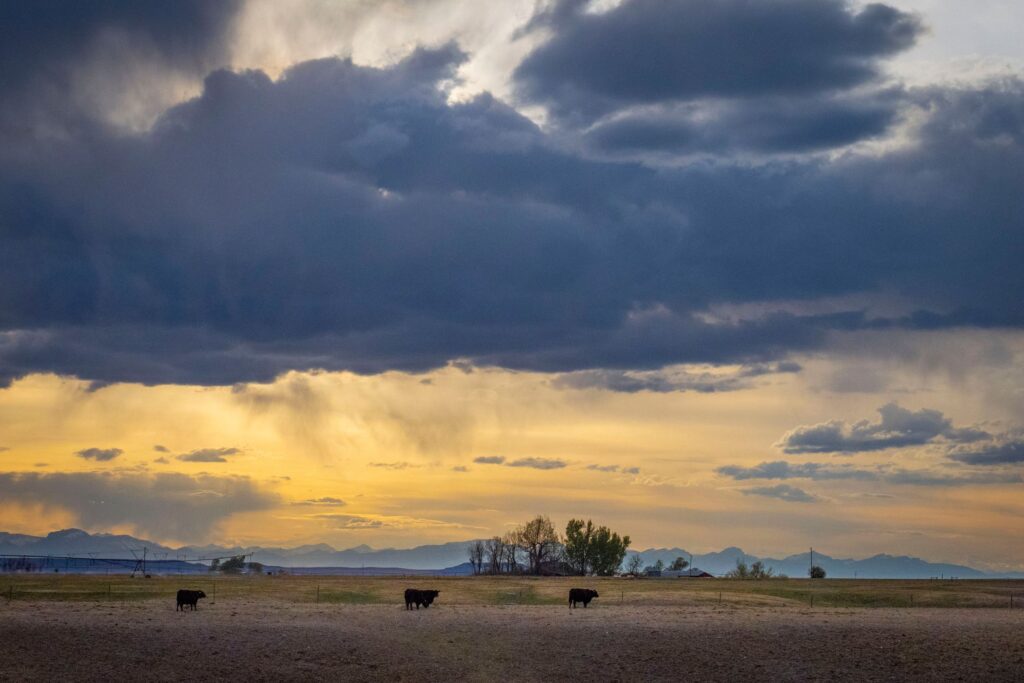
779;403;990;454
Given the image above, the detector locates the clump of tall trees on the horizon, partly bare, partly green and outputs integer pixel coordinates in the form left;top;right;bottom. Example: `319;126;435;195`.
469;515;630;577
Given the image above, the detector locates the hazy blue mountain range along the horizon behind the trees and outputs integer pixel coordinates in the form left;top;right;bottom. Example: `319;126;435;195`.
0;528;1024;579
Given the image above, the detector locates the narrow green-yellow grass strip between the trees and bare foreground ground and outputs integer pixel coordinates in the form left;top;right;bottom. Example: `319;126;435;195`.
0;574;1024;608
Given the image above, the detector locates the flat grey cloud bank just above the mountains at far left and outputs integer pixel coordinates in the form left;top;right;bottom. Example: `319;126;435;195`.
0;472;278;541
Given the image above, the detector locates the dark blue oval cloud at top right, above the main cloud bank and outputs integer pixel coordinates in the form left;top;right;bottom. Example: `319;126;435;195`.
515;0;922;118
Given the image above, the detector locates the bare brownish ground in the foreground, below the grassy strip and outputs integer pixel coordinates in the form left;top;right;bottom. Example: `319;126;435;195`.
0;593;1024;681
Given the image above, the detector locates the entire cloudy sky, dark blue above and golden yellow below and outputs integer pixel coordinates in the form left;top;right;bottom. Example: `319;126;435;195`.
0;0;1024;570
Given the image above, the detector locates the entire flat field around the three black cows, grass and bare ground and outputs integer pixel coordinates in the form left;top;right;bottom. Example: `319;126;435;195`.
0;575;1024;681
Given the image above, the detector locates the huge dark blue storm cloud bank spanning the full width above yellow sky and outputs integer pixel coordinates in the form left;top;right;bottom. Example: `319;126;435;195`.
0;30;1024;391
